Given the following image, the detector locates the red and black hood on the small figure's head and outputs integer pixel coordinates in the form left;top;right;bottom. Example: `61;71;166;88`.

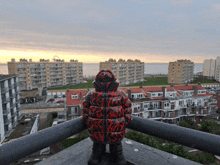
93;69;119;92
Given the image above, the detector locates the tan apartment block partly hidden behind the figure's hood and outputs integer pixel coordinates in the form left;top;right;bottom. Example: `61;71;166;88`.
99;59;144;85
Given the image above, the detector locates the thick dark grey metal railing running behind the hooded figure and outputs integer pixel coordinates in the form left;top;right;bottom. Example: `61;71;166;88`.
0;116;220;165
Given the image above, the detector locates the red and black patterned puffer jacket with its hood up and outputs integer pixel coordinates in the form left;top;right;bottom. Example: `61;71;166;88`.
83;69;132;144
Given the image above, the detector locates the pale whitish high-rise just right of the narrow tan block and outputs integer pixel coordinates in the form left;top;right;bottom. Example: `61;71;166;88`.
203;59;216;78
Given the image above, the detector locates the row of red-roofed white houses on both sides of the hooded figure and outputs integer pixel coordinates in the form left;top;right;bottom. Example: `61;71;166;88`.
66;83;217;123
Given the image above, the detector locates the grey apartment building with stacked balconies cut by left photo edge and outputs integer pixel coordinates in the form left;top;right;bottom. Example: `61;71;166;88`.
0;75;21;143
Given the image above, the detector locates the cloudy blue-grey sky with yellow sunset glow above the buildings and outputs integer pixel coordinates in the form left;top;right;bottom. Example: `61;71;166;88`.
0;0;220;63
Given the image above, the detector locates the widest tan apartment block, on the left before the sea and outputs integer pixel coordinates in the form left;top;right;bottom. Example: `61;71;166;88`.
8;59;83;90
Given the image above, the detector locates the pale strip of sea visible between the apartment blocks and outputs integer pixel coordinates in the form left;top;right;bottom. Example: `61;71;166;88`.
0;63;203;76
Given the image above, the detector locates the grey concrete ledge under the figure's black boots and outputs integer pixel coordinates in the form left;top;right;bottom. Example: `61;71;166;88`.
36;138;199;165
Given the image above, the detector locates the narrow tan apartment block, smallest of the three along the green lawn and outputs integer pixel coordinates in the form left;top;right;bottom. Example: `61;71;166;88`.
168;60;194;84
